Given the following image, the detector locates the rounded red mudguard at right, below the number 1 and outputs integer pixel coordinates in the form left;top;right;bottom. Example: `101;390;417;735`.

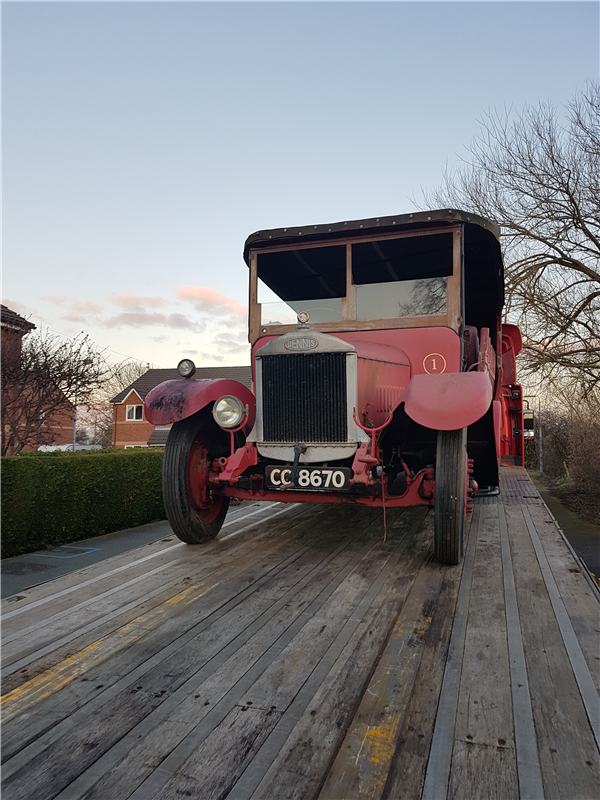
402;372;492;431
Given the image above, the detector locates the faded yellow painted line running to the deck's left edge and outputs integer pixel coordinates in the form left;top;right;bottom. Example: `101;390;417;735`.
0;581;220;724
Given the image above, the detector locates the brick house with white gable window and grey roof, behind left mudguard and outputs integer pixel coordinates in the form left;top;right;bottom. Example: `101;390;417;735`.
110;367;252;448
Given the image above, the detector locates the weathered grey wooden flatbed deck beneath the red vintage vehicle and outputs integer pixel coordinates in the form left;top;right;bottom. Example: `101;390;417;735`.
0;468;600;800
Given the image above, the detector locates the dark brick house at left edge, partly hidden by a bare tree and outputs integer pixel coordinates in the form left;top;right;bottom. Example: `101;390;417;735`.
0;304;73;455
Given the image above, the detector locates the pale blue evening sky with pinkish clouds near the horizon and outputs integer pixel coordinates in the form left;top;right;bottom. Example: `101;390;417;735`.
0;0;600;367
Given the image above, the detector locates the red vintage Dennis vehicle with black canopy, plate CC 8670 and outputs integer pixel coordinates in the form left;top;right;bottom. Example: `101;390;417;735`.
146;210;523;564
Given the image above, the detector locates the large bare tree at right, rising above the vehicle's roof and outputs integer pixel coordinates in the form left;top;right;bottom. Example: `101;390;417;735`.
425;82;600;395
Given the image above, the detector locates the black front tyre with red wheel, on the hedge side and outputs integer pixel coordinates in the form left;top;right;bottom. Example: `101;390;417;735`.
162;412;229;544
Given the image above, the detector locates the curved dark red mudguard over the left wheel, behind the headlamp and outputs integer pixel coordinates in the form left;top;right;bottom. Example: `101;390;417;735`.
144;378;256;430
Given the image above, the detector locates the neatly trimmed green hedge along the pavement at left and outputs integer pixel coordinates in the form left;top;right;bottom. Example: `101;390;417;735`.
0;448;166;558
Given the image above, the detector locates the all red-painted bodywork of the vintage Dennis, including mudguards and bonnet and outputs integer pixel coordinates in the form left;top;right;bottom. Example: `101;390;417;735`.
146;326;523;507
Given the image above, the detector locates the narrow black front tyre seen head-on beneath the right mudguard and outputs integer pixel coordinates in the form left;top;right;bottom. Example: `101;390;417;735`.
434;428;467;564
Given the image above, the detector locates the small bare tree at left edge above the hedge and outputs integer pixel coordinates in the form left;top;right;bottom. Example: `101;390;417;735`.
0;333;107;455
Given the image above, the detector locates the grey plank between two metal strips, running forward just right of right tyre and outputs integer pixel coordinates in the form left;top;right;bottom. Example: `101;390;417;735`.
448;505;519;800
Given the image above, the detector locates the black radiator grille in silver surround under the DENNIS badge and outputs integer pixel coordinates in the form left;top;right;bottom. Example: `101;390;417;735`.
262;353;348;443
